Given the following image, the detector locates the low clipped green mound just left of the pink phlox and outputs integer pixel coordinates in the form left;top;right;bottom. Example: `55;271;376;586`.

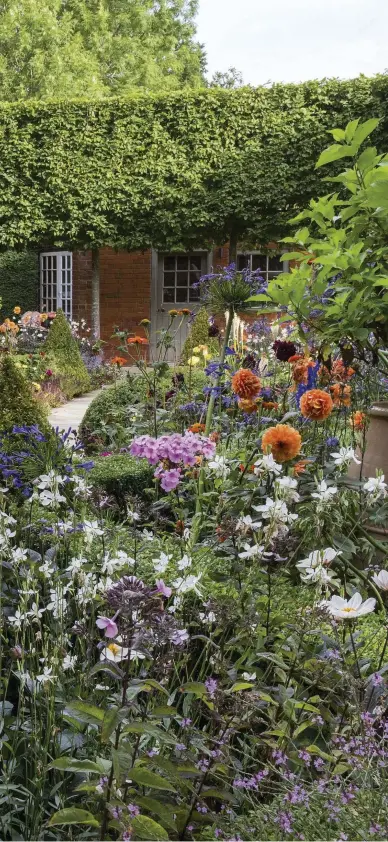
88;454;153;499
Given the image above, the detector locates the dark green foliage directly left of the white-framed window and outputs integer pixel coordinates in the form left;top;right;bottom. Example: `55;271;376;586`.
0;251;39;319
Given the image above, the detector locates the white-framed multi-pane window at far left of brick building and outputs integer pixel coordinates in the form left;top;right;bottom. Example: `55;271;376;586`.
40;251;73;319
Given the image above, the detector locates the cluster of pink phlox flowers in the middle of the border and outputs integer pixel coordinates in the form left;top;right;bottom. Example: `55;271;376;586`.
130;432;216;491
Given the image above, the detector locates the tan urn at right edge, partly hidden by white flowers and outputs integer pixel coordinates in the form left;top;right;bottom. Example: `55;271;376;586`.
348;401;388;540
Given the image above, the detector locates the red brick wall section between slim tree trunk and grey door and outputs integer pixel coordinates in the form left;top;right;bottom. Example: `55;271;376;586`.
100;248;151;340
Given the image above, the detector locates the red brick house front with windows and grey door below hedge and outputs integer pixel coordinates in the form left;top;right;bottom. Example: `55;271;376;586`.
40;246;286;352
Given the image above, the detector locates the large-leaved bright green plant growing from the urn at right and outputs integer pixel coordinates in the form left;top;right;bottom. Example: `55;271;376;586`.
252;119;388;366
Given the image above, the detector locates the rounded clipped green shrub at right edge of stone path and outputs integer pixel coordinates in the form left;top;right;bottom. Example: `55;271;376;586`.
79;377;140;448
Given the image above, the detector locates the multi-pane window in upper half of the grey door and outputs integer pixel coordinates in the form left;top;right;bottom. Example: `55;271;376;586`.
163;253;206;304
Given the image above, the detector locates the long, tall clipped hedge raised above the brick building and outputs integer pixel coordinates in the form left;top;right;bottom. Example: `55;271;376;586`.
0;76;388;249
